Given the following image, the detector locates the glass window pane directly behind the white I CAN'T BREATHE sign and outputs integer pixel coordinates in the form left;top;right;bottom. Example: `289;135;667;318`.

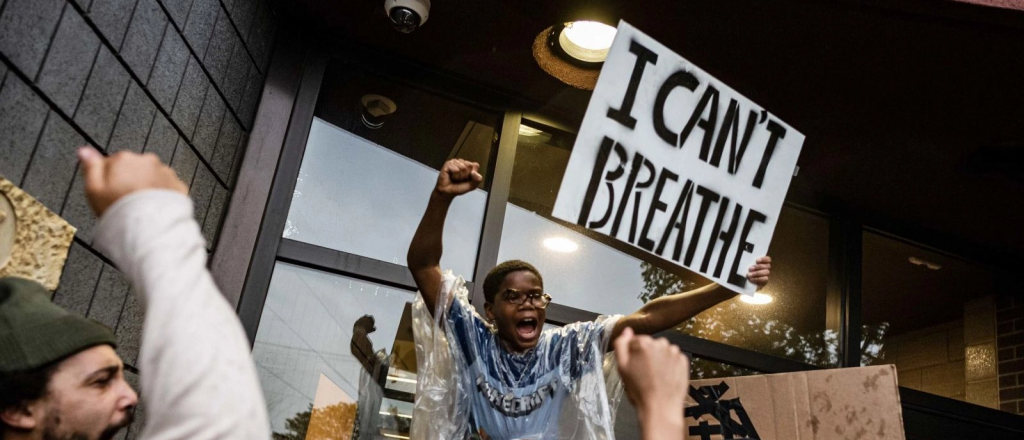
498;118;839;365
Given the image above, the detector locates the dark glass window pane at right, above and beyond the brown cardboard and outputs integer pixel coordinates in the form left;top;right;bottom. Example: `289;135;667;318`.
862;232;1017;411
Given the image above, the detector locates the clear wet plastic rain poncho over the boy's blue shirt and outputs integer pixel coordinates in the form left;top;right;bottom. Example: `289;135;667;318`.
411;271;622;440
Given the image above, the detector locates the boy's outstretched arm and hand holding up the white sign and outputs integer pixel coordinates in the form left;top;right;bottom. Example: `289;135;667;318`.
611;257;771;340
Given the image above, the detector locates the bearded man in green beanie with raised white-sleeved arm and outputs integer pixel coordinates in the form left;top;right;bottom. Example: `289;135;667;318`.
0;147;270;440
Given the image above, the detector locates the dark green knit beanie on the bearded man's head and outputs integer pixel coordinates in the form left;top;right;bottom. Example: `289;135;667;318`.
0;276;117;373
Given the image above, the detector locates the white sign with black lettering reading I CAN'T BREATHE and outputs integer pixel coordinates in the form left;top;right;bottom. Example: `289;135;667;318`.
553;21;804;294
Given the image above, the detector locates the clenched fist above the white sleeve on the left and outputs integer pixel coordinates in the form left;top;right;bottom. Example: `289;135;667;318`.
78;146;188;216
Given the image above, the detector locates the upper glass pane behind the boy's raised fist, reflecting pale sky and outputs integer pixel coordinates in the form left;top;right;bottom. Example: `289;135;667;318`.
284;65;499;279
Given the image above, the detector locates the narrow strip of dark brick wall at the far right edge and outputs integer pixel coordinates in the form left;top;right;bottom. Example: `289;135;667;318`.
995;294;1024;414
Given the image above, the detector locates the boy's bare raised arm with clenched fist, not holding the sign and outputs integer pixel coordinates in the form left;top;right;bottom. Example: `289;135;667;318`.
407;159;483;313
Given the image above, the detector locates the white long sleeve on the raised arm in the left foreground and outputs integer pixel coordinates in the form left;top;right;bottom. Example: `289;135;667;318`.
94;190;270;440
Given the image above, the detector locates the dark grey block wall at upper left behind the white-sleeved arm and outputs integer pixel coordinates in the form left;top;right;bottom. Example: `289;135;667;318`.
0;0;275;438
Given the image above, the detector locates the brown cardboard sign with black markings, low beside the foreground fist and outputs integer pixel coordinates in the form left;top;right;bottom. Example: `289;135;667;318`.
686;365;905;440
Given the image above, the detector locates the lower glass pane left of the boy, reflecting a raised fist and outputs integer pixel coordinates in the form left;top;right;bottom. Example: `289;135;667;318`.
253;263;416;438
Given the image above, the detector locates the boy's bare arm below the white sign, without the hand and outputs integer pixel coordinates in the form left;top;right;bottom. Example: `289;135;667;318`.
623;283;736;335
